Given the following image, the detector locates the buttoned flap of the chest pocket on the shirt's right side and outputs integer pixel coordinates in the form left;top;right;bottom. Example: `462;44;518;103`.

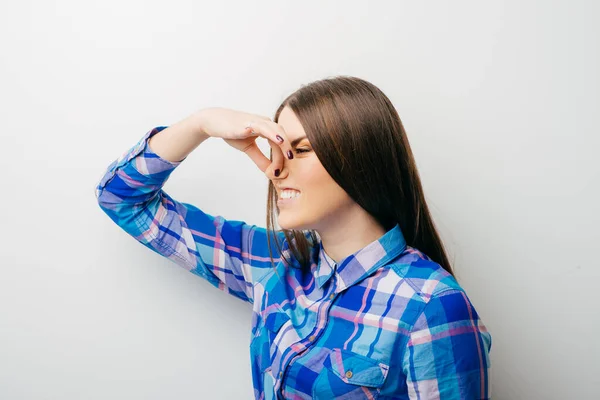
329;349;389;388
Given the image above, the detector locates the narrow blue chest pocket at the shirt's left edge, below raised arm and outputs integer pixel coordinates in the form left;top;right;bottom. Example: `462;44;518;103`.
250;305;290;372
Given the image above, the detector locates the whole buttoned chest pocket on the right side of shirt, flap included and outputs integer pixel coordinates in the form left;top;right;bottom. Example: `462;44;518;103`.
312;349;389;399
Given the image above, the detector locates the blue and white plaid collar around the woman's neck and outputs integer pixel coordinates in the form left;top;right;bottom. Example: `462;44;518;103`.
314;224;406;292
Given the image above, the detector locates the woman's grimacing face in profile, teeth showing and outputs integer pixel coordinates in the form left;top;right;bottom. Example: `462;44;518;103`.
273;107;356;231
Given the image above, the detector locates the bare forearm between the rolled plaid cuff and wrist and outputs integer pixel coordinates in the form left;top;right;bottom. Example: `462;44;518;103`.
148;110;210;162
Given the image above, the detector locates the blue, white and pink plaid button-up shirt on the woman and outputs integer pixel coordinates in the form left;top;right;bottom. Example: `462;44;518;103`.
96;127;491;400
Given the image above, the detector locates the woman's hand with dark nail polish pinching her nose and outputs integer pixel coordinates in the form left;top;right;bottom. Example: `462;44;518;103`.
200;107;293;179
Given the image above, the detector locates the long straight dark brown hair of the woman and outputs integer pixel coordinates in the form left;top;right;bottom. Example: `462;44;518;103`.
267;76;454;275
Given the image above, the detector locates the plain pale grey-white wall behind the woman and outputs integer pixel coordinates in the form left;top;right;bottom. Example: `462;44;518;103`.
0;0;600;400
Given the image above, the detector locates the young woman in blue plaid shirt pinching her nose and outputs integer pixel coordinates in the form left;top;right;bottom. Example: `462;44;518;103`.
96;76;491;400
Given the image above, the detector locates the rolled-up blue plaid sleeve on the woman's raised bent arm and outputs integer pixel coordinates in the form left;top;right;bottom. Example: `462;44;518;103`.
95;126;284;302
